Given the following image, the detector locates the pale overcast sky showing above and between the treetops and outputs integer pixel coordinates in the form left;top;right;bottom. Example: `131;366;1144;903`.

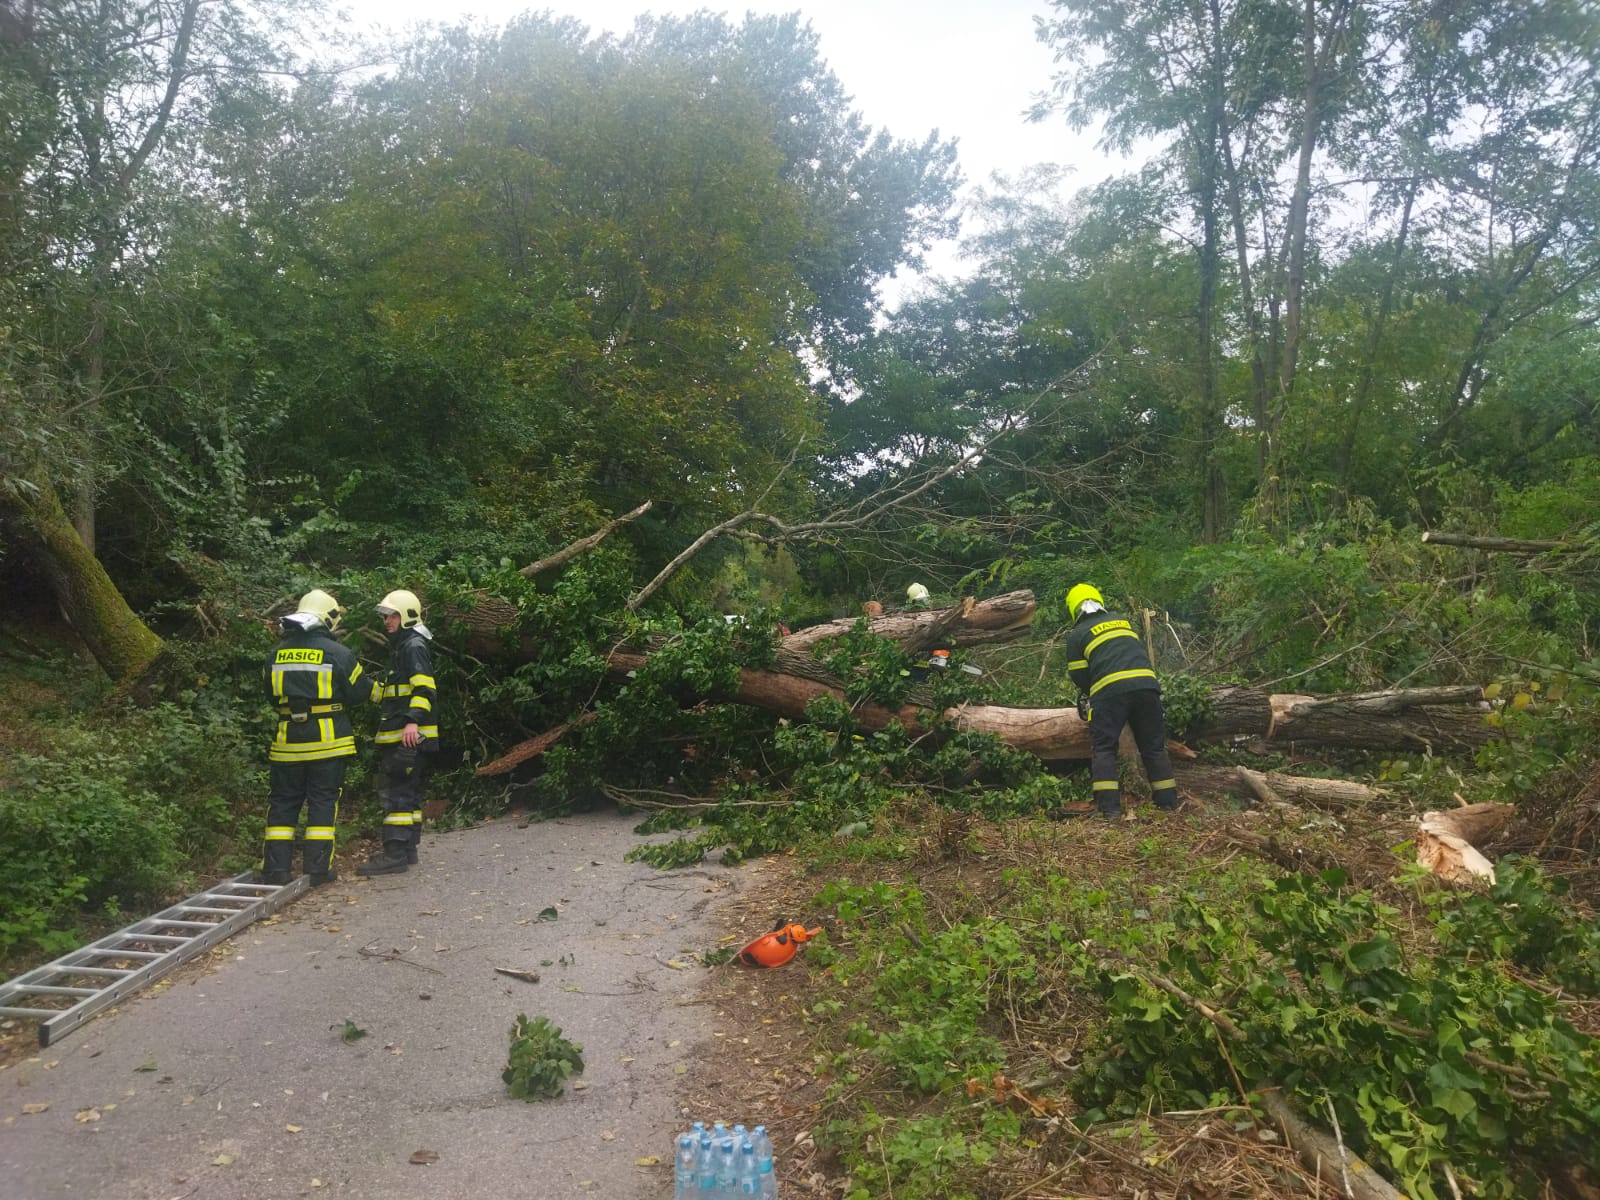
332;0;1126;306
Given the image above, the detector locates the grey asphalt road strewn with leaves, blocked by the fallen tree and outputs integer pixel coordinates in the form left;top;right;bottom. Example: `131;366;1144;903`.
0;813;741;1200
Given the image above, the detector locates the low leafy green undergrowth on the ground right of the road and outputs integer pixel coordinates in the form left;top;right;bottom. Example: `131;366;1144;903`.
808;830;1600;1200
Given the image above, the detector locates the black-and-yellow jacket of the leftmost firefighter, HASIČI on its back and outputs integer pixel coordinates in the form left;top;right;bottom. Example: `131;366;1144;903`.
264;622;365;763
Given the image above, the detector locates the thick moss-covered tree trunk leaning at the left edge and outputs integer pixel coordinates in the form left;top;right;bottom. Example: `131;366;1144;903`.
0;472;162;683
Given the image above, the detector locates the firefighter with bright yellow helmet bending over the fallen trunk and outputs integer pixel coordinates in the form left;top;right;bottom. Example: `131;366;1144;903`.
1067;584;1178;821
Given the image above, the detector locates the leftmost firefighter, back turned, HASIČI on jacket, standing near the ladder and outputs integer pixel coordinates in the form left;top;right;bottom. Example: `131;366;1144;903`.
261;589;366;886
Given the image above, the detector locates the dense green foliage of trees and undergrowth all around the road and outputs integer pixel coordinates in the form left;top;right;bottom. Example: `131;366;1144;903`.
0;0;1600;1197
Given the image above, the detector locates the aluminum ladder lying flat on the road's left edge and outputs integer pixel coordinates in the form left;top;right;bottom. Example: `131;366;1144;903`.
0;872;310;1046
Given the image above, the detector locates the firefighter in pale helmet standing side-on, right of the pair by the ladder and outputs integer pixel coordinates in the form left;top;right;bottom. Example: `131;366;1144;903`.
355;590;438;875
